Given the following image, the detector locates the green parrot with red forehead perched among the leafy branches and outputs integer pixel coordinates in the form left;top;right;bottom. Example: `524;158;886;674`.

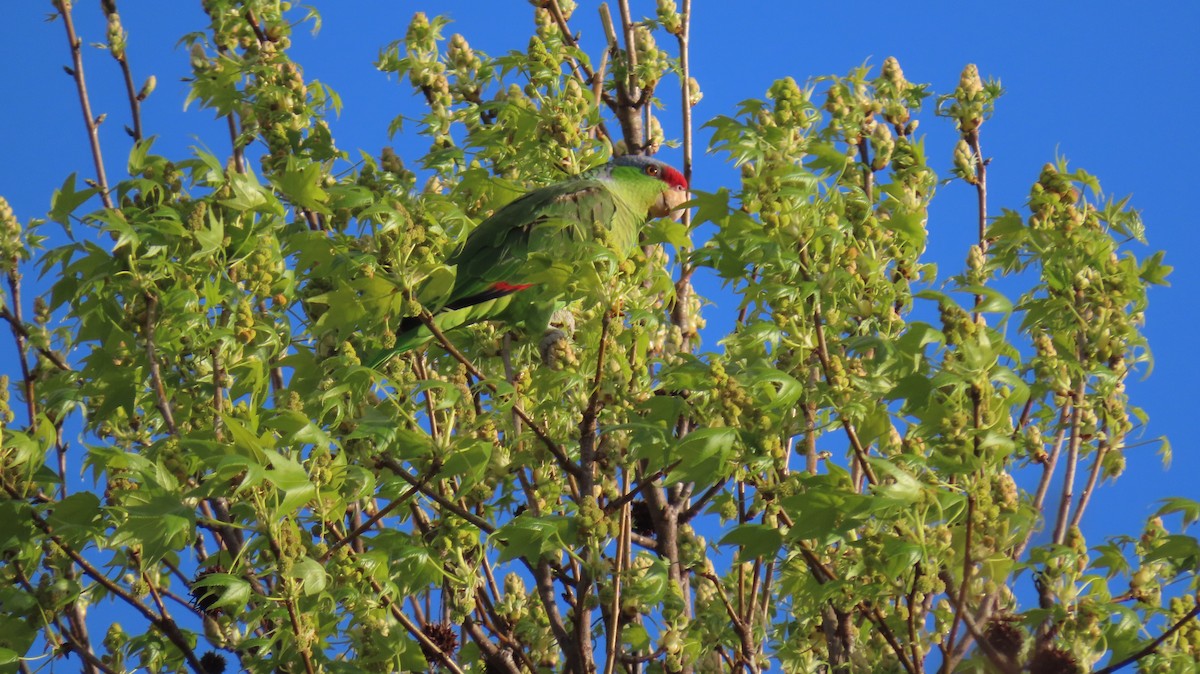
367;155;688;368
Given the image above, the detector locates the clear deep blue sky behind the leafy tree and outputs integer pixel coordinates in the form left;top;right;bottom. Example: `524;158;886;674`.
0;0;1200;657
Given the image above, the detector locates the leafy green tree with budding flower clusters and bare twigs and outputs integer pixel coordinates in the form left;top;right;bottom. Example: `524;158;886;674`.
0;0;1200;674
